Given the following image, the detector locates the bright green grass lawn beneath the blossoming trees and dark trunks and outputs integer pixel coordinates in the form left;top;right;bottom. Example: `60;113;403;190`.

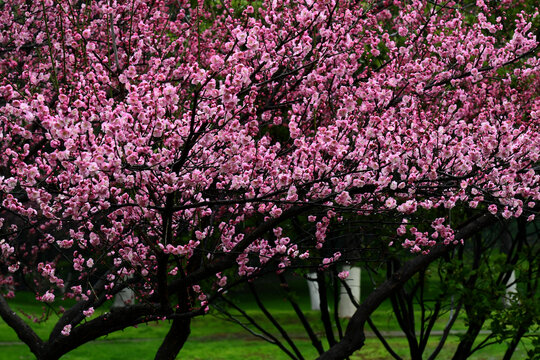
0;278;526;360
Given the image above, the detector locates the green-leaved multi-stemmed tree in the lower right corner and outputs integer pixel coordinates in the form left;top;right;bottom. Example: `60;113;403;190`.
354;219;539;359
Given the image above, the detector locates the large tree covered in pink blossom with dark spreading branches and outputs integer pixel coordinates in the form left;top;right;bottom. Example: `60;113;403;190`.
0;0;540;359
